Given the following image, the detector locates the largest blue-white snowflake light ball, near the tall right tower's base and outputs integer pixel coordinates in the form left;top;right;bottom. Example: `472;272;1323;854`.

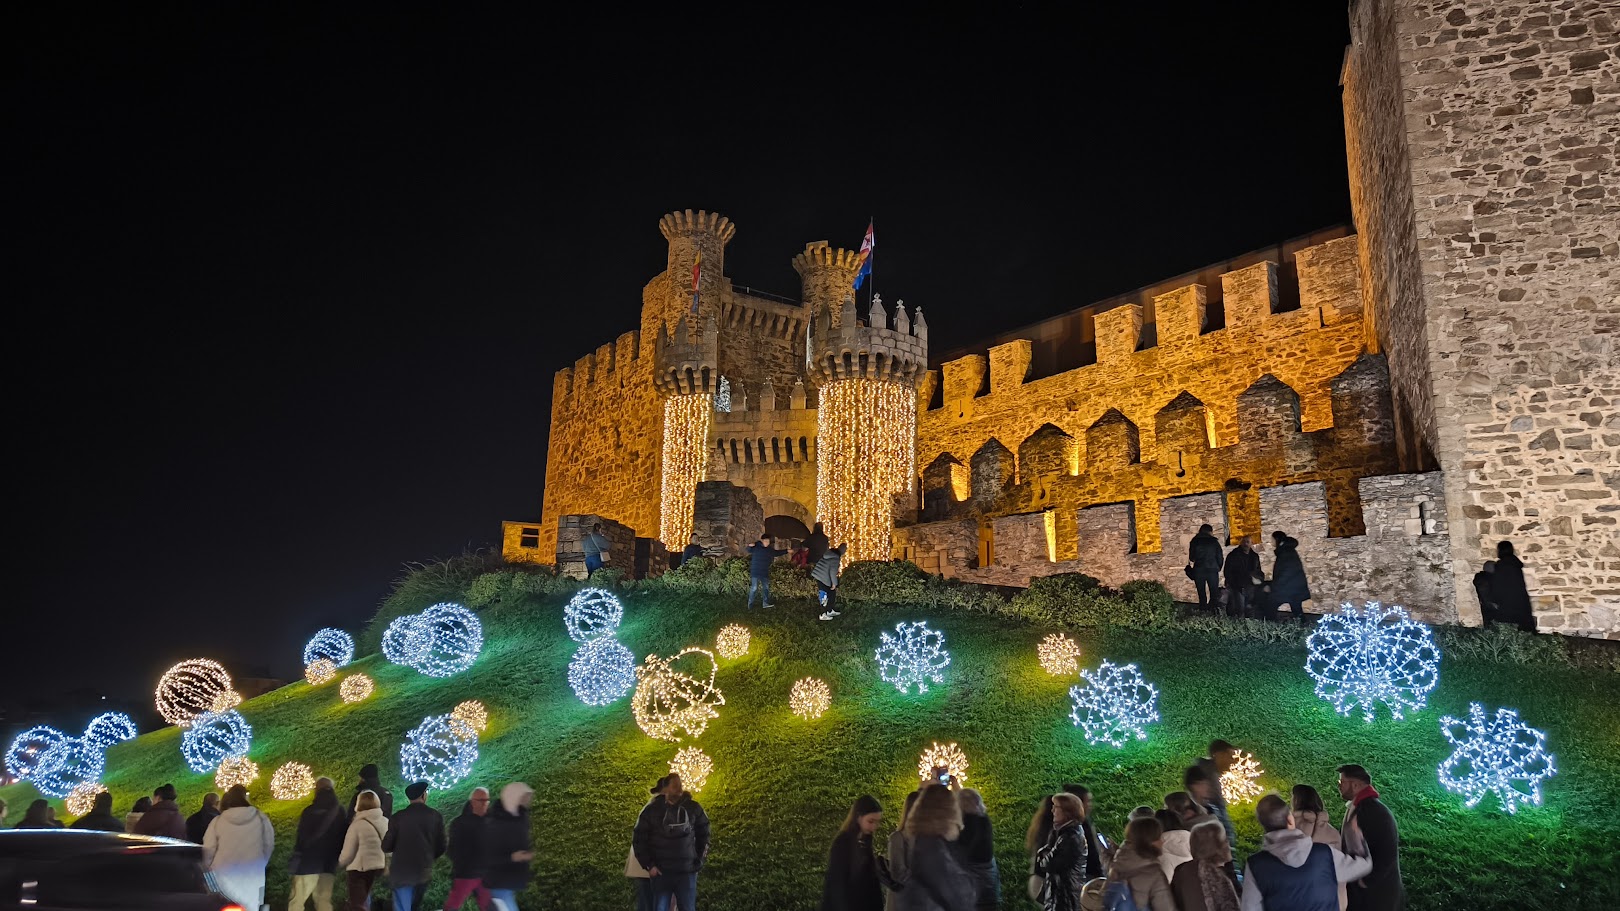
1306;601;1440;721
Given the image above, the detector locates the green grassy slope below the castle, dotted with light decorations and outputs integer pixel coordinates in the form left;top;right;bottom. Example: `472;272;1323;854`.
0;567;1620;911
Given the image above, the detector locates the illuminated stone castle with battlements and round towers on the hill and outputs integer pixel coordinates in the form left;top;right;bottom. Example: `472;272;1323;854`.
504;0;1620;635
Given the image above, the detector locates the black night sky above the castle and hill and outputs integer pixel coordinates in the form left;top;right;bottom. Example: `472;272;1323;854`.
0;3;1349;728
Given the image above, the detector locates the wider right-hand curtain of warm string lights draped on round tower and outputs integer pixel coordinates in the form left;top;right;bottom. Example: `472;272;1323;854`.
815;378;917;562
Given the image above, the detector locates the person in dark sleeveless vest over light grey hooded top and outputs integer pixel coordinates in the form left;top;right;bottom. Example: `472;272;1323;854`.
1241;794;1372;911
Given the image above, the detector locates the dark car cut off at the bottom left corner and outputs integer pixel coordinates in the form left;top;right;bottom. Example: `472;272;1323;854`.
0;828;243;911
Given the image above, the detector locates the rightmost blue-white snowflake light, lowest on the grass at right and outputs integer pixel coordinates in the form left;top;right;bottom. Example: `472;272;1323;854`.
1439;702;1558;814
